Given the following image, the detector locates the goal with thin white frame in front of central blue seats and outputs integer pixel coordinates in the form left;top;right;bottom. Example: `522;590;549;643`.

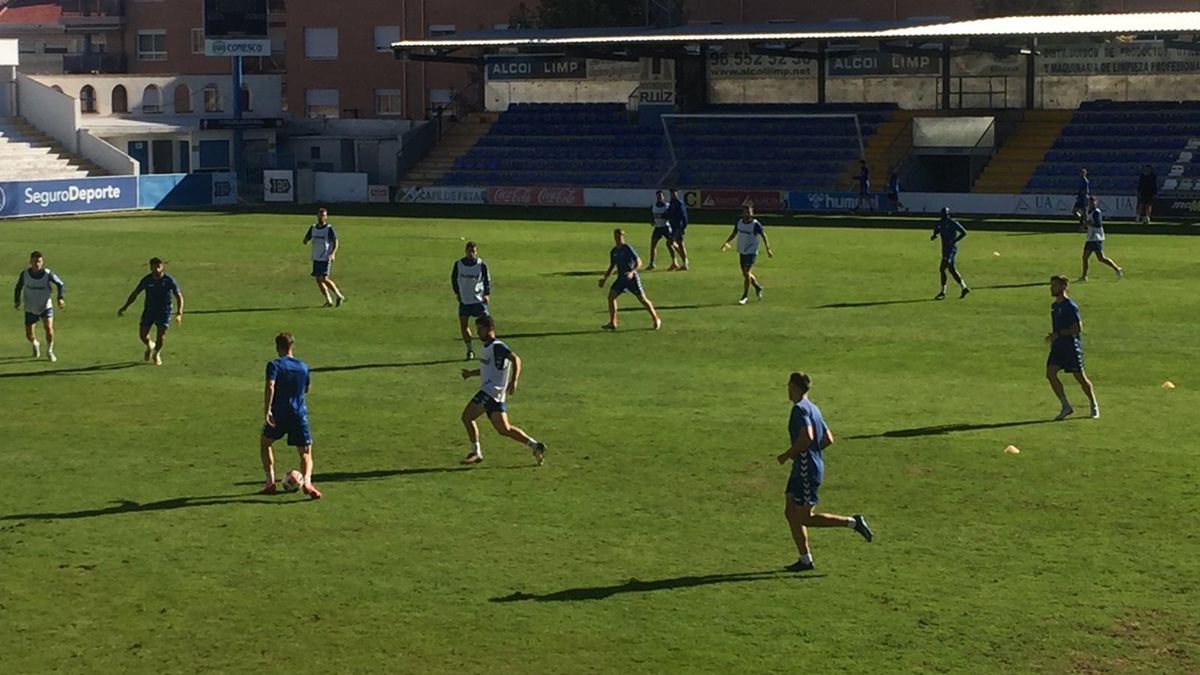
659;113;865;191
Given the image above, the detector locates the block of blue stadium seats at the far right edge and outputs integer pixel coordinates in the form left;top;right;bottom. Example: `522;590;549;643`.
1025;101;1200;193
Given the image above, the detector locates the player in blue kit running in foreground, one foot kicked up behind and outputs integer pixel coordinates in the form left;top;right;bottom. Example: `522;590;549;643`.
775;372;874;572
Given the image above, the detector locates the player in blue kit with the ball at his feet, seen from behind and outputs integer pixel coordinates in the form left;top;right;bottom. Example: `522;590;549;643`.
259;333;320;500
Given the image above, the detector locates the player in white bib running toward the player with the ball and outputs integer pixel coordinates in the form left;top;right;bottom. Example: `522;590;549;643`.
462;316;546;466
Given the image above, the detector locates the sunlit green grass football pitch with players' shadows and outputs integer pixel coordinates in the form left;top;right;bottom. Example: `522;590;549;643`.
0;209;1200;674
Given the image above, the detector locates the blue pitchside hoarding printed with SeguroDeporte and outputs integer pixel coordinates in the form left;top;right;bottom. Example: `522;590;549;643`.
0;175;138;217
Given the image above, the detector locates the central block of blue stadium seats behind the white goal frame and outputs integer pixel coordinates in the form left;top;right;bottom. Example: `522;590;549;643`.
439;103;896;190
